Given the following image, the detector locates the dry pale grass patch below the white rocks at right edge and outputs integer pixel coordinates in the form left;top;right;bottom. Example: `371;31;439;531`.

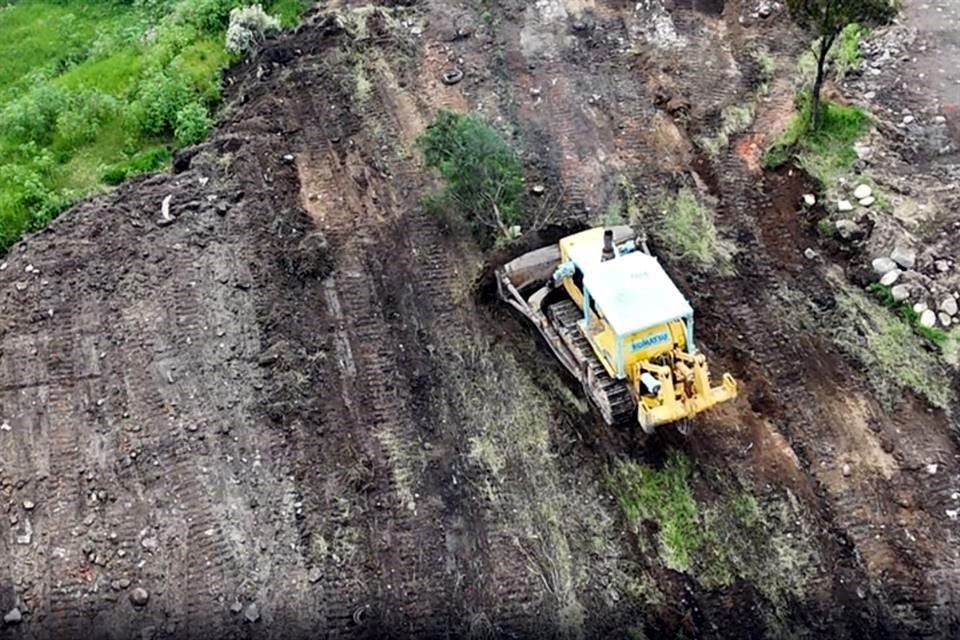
833;283;955;414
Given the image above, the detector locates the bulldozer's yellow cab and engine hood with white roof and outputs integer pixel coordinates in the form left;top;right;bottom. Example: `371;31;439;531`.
560;229;694;379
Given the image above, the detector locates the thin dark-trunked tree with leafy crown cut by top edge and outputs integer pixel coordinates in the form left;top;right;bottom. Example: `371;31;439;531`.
787;0;900;131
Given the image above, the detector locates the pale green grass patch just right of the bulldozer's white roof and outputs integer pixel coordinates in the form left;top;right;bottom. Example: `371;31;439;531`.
651;188;733;272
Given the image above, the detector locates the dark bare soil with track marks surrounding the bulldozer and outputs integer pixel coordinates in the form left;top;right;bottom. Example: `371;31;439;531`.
0;0;960;639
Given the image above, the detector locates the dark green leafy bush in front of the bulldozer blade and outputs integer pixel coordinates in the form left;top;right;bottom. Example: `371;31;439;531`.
417;110;524;244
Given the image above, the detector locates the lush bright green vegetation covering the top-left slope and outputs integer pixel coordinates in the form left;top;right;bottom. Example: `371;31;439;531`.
0;0;306;250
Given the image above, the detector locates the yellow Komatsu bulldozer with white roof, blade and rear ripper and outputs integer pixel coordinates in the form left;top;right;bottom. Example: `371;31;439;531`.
496;225;737;434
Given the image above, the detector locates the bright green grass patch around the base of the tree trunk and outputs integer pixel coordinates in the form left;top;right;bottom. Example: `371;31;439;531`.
764;99;869;187
